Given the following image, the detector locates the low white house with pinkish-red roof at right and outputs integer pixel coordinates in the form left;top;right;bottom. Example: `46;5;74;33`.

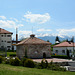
53;41;75;56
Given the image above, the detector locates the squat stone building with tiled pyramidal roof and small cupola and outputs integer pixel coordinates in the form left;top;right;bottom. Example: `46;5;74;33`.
16;34;51;58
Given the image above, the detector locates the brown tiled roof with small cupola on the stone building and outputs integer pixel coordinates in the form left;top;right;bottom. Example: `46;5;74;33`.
17;35;51;45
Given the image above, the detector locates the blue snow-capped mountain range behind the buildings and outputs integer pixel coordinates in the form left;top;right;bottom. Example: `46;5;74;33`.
38;36;72;44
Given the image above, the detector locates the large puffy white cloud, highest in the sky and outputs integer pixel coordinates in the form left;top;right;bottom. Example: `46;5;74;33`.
24;11;50;24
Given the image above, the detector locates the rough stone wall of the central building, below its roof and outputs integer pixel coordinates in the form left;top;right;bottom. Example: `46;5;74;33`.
17;44;51;58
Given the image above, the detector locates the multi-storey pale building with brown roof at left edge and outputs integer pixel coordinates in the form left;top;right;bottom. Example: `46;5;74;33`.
0;28;13;50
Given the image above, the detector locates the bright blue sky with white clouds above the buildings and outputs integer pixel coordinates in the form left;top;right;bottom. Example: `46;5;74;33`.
0;0;75;38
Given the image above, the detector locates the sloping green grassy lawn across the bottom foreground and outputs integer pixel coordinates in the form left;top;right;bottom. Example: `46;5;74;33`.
0;64;75;75
